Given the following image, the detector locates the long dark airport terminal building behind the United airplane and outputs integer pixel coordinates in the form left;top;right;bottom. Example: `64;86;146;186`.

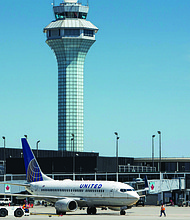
0;148;190;205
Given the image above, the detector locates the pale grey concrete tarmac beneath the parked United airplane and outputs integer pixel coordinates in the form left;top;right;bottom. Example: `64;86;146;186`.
1;206;190;220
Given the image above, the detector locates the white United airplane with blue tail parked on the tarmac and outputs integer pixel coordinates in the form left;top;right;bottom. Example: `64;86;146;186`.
1;138;140;215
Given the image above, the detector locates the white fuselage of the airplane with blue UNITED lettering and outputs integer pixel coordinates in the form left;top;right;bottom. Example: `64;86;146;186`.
26;180;139;207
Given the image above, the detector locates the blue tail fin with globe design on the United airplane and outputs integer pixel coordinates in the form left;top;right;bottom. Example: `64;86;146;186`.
21;138;52;182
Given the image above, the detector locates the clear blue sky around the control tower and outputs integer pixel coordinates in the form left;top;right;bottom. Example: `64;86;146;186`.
0;0;190;157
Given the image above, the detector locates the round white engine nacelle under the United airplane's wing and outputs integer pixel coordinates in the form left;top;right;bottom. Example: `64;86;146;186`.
55;198;78;212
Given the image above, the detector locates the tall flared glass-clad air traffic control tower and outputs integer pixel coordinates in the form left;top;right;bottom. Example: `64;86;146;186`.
44;0;98;151
